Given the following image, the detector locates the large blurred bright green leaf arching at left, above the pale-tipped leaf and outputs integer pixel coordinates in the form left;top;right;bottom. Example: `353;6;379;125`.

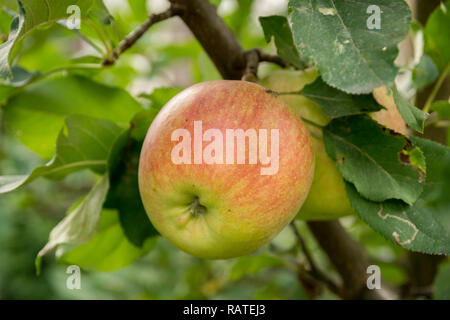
3;75;142;159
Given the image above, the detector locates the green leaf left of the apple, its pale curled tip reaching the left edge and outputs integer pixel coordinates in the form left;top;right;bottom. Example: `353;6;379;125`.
0;116;124;193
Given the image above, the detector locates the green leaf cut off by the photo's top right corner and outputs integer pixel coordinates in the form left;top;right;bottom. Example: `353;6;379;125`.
424;1;450;70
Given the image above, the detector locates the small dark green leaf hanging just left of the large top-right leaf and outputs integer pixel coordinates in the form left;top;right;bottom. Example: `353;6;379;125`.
259;16;305;69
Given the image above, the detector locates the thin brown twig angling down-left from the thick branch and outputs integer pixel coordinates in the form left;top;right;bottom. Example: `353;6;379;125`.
103;5;182;66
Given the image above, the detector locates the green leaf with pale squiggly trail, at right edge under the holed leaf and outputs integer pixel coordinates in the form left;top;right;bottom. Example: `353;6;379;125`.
346;137;450;254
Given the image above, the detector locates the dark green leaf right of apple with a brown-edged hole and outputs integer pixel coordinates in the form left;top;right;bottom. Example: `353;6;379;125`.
323;116;424;204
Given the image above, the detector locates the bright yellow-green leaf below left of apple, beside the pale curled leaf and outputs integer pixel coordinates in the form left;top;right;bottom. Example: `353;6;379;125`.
59;210;157;272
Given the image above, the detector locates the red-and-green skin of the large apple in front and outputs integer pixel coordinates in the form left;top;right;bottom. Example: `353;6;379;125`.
139;80;314;259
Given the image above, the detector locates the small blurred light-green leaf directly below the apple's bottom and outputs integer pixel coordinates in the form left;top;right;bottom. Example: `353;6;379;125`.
230;255;285;281
